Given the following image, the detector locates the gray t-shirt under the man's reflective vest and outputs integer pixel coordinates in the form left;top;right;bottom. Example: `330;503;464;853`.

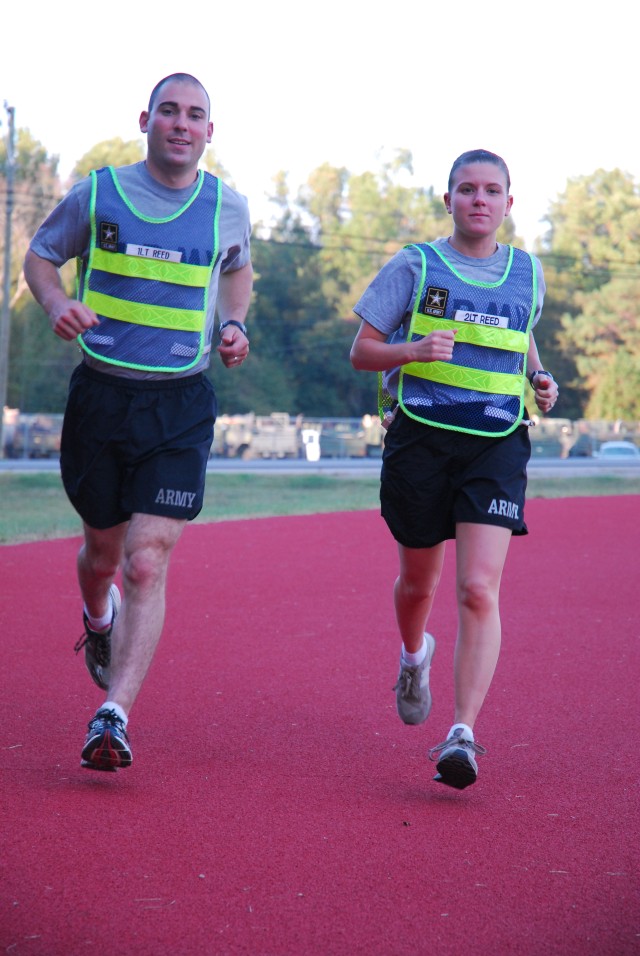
30;162;251;379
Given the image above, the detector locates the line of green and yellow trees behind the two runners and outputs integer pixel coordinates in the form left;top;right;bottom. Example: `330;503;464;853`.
0;130;640;421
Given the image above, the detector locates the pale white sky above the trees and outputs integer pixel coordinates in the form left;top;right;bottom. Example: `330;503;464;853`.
0;0;640;248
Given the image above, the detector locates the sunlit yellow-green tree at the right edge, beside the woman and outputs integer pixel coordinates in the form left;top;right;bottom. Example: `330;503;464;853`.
545;170;640;419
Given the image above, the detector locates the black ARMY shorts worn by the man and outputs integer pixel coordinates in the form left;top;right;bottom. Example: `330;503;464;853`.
60;364;216;529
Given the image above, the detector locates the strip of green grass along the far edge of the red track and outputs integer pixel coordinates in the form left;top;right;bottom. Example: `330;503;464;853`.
0;472;640;544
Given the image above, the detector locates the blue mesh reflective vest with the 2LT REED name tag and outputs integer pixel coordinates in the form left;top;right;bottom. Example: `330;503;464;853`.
398;243;538;437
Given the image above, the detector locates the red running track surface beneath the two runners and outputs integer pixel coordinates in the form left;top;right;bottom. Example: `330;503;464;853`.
0;496;640;956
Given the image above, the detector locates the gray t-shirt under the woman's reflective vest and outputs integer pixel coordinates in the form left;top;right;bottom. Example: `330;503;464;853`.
353;238;546;395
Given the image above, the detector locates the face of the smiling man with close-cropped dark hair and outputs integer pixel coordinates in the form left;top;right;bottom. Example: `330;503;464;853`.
140;80;213;176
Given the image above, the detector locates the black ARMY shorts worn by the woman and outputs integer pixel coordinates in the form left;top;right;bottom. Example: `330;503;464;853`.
380;410;531;548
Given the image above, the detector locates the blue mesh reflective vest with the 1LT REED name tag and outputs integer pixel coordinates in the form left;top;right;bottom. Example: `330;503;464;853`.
78;166;221;372
